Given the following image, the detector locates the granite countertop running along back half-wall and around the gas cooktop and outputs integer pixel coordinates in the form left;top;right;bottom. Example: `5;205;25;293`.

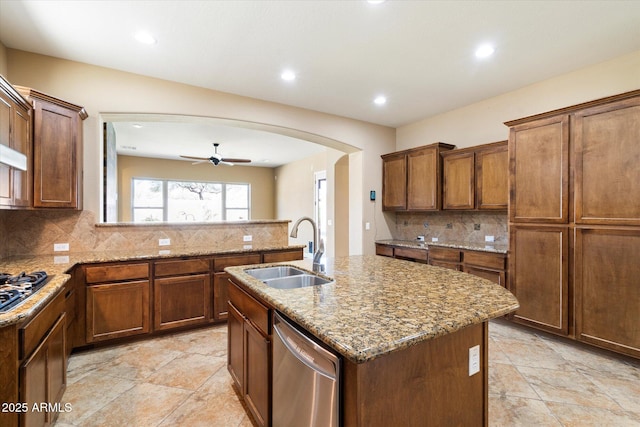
0;244;306;327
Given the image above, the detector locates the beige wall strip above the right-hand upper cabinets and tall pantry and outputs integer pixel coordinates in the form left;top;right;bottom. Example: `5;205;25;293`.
396;51;640;150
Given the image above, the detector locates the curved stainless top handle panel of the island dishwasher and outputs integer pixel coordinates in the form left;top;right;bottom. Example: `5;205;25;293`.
273;313;340;381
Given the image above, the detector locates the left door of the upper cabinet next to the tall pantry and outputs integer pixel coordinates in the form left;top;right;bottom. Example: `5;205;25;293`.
442;151;476;209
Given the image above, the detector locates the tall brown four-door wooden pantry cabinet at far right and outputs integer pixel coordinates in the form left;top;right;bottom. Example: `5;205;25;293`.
506;90;640;357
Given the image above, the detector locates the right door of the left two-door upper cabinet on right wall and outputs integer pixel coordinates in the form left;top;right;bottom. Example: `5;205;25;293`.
407;147;441;211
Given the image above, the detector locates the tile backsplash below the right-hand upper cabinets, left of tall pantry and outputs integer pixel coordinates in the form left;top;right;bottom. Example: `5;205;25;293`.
387;211;509;244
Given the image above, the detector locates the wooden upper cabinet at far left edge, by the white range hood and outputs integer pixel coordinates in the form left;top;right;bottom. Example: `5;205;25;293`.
0;76;33;208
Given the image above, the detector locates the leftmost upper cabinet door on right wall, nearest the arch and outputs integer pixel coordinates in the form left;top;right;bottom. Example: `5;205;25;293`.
382;153;407;211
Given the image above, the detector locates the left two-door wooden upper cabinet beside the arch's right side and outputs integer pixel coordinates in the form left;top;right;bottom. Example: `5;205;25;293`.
382;142;455;211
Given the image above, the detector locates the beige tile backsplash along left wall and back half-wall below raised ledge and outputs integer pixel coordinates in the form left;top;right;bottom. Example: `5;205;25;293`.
0;210;289;258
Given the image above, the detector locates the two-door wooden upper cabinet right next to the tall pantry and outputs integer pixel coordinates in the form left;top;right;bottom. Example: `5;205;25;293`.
442;141;509;210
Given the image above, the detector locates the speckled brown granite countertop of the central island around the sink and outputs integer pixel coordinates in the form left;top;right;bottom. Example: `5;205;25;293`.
225;255;518;363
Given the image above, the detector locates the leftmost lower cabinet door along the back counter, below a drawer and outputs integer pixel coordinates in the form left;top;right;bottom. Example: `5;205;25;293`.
86;280;151;342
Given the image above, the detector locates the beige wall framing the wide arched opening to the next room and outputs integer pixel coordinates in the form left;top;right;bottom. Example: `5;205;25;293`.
7;49;395;254
